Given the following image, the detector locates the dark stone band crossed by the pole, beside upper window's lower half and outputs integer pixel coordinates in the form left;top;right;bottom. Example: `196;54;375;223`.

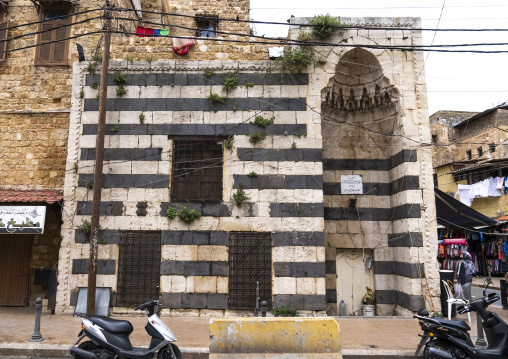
78;173;169;188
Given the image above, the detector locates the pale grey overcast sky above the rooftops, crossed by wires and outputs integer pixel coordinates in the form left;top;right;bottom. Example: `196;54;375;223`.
251;0;508;115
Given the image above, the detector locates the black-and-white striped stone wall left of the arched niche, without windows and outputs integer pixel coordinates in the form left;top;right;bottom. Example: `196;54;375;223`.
57;61;325;315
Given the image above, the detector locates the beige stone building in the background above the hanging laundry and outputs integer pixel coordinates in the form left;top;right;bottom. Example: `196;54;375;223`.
430;104;508;218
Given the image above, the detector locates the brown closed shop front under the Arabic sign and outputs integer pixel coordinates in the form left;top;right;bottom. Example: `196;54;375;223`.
0;234;33;307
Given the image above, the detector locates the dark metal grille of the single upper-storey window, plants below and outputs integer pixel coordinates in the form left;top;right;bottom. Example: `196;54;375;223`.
171;140;223;202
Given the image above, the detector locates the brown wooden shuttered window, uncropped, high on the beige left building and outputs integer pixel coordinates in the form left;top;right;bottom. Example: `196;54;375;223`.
35;5;71;66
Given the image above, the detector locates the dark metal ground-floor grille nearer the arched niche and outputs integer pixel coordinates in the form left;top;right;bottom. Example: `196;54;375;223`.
229;232;272;309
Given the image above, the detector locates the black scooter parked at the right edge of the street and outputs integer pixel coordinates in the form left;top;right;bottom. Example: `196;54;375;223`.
414;278;508;359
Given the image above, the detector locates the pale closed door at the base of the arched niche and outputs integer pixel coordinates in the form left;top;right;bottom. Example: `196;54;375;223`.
336;249;375;315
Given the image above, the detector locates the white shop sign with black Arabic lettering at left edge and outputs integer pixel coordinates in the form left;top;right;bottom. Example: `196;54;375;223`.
0;206;46;234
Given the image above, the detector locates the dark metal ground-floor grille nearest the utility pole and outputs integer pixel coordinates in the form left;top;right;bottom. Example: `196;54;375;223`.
117;231;161;307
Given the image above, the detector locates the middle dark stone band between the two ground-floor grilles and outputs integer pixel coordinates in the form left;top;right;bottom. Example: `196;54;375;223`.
161;261;229;277
